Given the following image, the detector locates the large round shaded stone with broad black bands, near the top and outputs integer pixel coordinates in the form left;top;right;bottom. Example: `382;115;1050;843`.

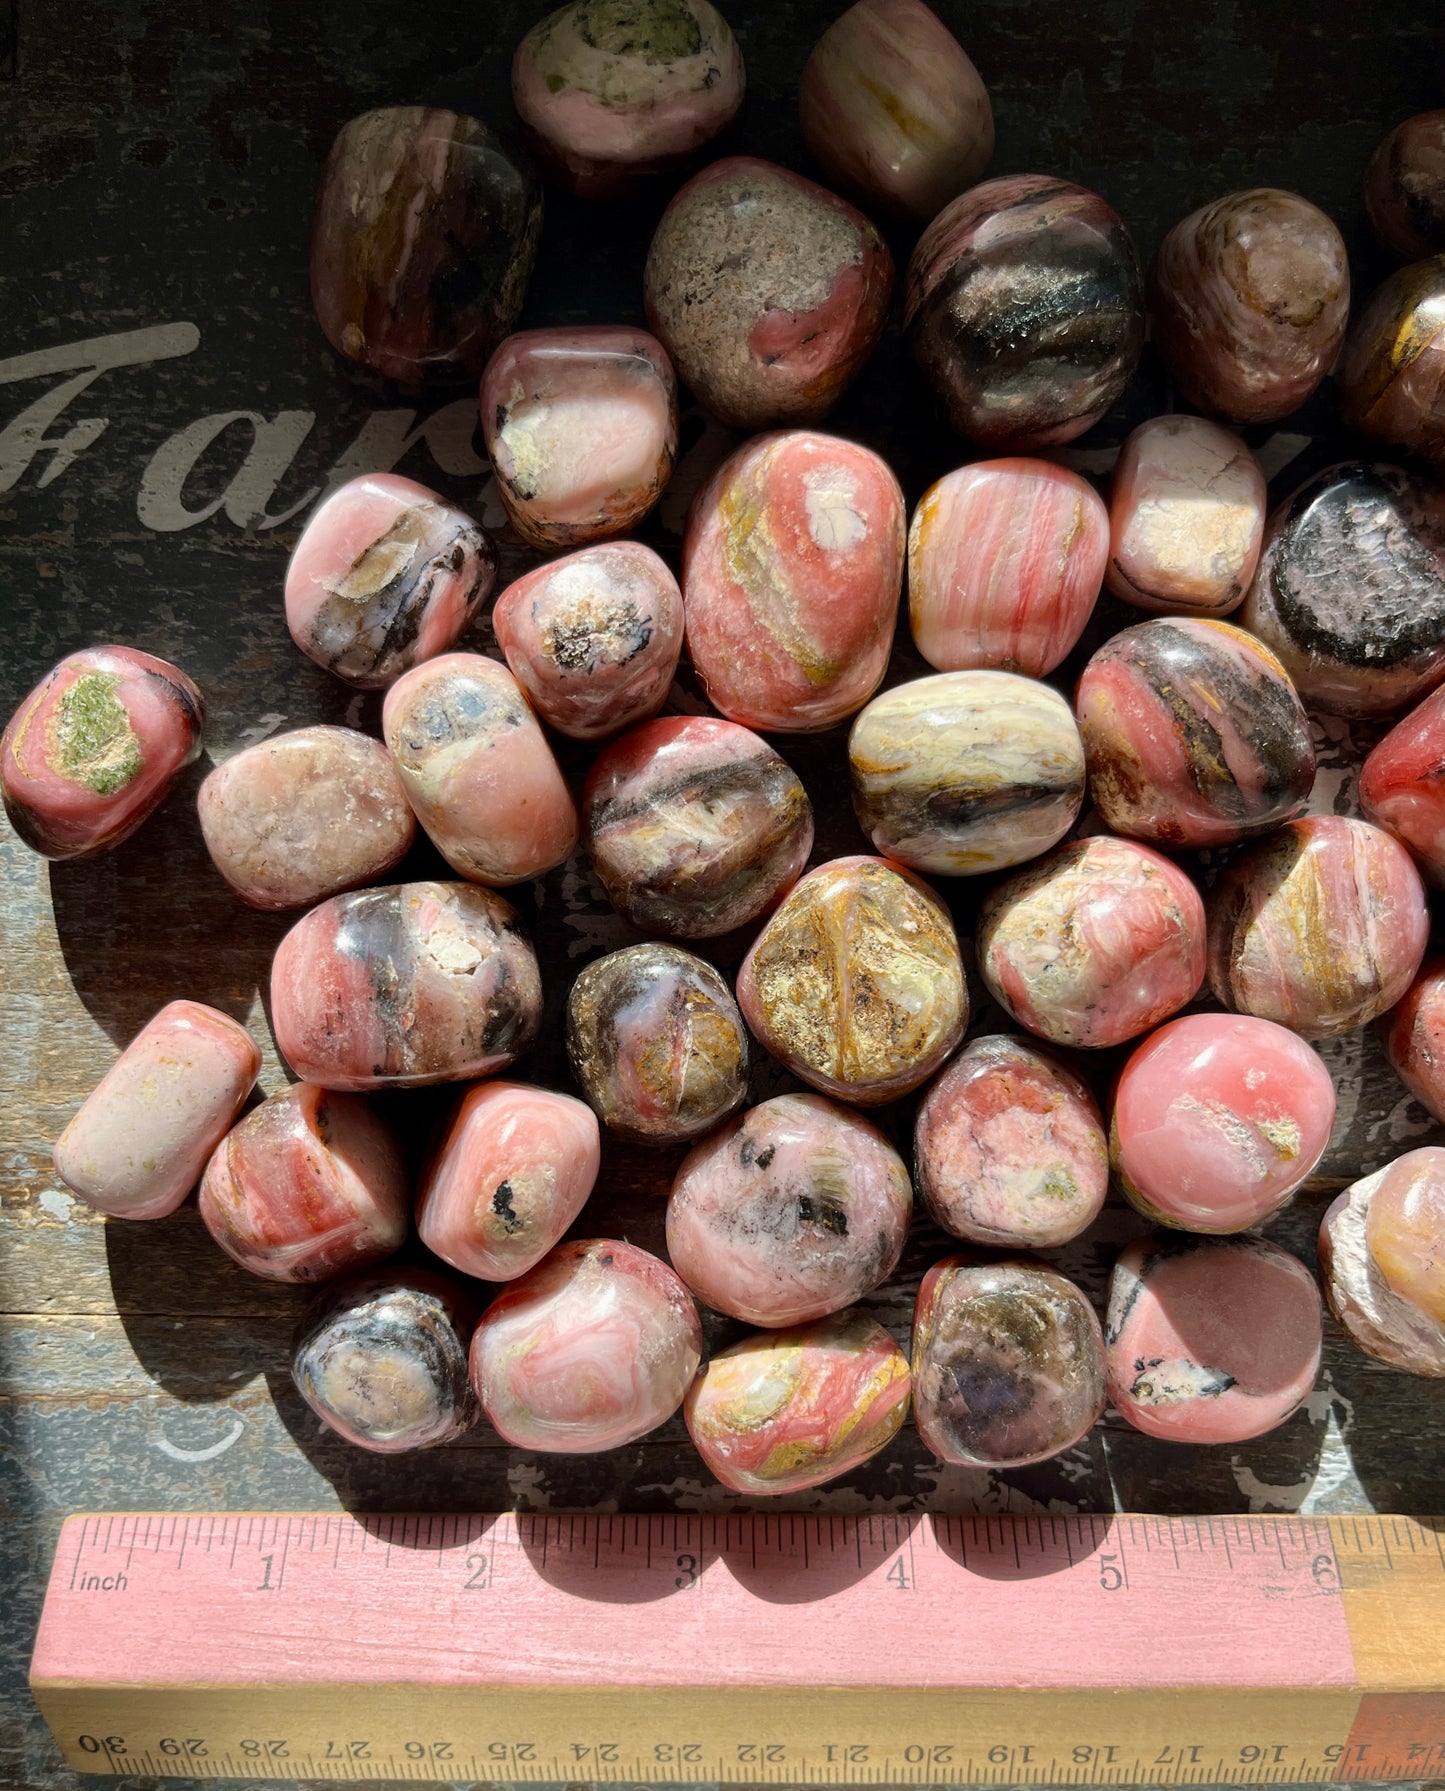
902;174;1144;453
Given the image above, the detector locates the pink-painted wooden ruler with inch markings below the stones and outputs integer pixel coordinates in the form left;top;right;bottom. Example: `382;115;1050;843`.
30;1513;1445;1786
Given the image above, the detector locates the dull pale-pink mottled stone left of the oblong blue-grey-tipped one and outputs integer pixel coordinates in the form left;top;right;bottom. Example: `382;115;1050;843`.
197;727;417;908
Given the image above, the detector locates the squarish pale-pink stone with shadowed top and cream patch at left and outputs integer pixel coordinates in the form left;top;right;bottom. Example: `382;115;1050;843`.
482;324;677;548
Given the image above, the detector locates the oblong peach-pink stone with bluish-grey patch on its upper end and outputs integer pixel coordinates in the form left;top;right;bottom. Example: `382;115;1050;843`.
381;654;578;888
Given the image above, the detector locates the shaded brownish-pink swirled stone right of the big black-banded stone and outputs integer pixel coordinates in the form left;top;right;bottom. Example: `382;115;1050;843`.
1150;186;1350;423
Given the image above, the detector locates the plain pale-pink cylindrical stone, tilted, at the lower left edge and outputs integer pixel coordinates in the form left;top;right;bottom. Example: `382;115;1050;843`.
56;1001;261;1220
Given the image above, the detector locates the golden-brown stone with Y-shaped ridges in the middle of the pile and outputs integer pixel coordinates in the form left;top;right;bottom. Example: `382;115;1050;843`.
738;858;969;1107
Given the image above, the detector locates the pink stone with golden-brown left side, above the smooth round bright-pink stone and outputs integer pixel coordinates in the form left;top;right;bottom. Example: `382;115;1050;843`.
1209;815;1429;1039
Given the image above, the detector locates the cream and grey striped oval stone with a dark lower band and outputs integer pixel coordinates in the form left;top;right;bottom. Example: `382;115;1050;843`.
849;672;1083;876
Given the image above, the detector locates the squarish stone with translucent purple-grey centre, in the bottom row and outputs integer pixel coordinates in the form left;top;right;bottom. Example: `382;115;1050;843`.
913;1255;1105;1467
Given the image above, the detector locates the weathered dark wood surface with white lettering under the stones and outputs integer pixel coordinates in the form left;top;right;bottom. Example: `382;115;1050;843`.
0;0;1445;1791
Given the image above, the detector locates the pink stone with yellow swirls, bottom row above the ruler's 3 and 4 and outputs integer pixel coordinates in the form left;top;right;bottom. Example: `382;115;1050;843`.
682;1311;910;1494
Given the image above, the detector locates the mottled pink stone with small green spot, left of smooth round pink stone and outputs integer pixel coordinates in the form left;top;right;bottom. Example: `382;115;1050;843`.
913;1035;1108;1250
